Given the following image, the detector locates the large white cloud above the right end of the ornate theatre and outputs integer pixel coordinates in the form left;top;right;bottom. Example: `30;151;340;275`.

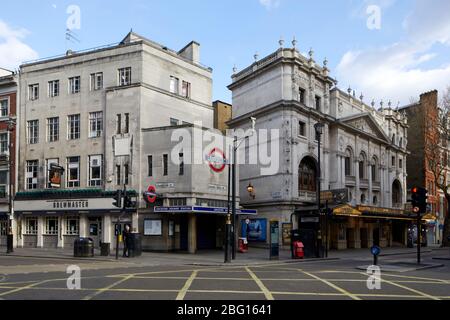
336;0;450;104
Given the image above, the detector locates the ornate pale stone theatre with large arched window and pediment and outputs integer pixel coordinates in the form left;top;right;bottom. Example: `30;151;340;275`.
229;42;407;254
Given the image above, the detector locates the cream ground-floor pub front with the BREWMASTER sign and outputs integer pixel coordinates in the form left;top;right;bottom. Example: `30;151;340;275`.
14;189;137;249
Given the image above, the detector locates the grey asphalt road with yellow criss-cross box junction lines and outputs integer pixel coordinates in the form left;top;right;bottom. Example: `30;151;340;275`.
0;251;450;301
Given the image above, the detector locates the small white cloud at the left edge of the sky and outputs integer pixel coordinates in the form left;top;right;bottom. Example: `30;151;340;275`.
0;20;38;70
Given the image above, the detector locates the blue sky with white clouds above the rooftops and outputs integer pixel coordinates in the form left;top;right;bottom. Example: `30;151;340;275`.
0;0;450;104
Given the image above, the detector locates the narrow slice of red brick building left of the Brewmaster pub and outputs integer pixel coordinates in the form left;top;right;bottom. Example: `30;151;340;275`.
0;68;17;246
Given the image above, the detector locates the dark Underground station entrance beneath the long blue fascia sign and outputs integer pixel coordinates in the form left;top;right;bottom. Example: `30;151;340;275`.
139;206;257;254
